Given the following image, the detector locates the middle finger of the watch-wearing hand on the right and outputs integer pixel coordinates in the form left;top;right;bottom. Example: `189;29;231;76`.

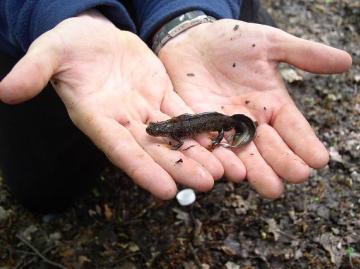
255;124;310;183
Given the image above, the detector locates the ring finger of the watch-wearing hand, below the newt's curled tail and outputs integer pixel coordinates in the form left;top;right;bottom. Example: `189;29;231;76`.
234;143;284;199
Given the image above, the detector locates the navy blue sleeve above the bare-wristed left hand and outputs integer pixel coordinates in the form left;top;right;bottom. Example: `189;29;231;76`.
0;0;135;56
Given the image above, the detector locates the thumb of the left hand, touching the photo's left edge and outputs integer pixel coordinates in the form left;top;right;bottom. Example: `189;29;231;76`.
0;33;60;104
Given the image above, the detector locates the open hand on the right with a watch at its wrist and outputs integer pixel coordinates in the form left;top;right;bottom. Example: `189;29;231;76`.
159;20;351;198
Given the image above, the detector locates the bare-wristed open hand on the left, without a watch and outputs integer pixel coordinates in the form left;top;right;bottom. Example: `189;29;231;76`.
0;11;224;199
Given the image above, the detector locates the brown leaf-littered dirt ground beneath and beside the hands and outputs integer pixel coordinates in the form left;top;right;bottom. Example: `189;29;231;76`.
0;0;360;269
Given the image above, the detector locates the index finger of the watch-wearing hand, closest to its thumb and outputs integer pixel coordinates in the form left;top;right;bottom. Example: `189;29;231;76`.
271;103;329;168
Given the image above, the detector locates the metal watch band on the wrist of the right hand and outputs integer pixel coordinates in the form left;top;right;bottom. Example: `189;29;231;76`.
152;10;216;54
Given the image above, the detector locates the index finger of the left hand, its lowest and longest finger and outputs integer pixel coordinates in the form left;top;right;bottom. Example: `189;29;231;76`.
78;116;177;200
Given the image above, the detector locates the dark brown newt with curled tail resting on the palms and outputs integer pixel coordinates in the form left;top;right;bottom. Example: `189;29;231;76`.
146;112;257;150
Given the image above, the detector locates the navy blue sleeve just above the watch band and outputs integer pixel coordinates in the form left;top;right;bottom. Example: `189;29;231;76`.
133;0;242;42
